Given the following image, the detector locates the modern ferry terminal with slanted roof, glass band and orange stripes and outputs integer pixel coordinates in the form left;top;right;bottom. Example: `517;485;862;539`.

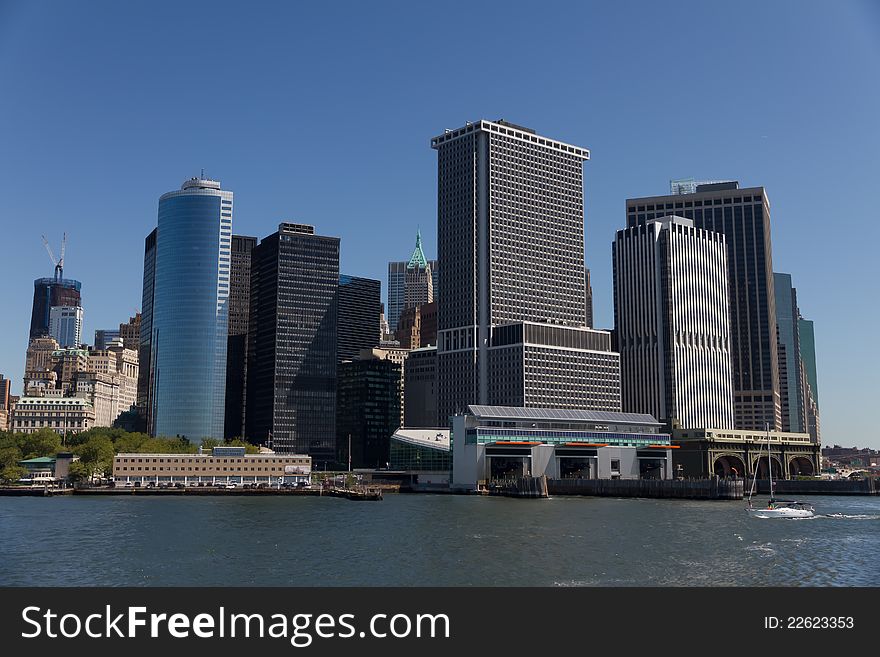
452;405;674;490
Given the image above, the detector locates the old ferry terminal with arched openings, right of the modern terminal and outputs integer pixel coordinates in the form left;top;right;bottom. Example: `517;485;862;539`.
672;428;821;480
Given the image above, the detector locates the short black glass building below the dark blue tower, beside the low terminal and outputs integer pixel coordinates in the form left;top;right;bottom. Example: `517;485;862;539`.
336;349;401;468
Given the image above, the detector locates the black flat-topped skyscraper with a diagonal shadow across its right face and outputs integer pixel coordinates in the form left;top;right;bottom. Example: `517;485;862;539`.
245;223;338;462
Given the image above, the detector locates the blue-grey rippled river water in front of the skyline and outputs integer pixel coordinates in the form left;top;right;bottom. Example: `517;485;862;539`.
0;494;880;586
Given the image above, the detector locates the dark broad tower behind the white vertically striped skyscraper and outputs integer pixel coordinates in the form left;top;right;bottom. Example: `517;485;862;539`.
626;181;782;430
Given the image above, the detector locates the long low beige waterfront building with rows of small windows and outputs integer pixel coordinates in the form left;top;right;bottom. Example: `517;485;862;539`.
113;447;312;486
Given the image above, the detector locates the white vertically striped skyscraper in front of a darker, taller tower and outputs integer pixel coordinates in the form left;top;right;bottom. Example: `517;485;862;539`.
612;216;733;429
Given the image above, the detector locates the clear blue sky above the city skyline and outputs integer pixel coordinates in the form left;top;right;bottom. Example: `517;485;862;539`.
0;0;880;448
